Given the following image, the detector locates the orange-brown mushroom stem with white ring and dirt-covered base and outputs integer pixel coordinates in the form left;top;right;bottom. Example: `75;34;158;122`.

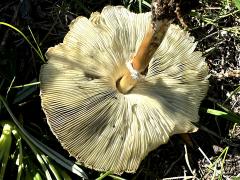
117;0;175;94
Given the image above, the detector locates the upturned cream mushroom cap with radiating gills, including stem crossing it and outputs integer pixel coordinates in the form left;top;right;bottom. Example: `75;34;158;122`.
40;0;208;174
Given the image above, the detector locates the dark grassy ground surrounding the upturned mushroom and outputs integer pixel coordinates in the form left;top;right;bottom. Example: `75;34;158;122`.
0;0;240;179
